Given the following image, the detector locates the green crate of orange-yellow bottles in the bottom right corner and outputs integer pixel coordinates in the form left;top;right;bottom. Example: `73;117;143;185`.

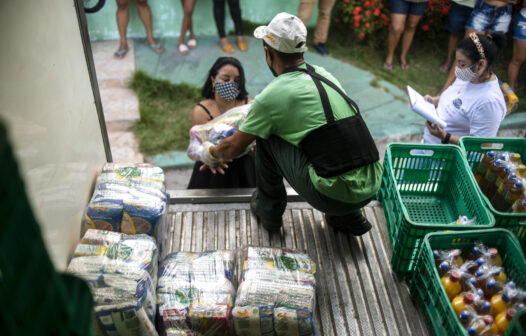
410;229;526;336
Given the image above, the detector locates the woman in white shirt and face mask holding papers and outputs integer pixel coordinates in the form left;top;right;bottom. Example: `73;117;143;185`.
423;33;506;144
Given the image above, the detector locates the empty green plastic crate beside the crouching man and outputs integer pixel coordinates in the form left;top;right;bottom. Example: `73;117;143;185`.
378;143;494;276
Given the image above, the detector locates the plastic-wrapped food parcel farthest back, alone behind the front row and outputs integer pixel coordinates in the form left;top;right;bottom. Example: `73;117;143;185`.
82;163;168;235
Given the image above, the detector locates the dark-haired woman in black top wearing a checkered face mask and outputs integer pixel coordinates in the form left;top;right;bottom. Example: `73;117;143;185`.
188;57;256;189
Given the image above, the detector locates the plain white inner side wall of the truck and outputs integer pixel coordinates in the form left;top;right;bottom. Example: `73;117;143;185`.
0;0;105;270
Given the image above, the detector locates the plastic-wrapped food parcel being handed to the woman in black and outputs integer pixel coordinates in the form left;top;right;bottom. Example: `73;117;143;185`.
186;104;252;161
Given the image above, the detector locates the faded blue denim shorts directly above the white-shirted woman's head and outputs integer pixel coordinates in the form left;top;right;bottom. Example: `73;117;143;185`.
466;0;513;33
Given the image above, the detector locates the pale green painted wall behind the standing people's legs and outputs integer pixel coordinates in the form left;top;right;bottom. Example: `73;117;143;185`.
86;0;317;41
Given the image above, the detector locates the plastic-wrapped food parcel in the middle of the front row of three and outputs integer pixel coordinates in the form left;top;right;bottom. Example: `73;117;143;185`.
157;250;235;336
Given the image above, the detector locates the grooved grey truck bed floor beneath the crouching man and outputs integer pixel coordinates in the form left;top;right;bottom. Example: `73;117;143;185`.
163;198;434;335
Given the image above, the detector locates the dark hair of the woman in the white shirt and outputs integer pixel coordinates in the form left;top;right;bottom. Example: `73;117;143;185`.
457;32;506;73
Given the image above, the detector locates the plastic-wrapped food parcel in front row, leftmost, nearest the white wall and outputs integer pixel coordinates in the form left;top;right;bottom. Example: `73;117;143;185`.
67;229;158;336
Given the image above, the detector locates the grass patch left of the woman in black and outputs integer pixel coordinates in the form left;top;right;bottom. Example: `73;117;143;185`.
130;71;201;155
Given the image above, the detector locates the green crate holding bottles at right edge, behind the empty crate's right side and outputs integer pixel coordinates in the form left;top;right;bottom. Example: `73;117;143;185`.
459;137;526;250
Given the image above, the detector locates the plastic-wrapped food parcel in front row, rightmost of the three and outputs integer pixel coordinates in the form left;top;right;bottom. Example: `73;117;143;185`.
232;247;316;336
